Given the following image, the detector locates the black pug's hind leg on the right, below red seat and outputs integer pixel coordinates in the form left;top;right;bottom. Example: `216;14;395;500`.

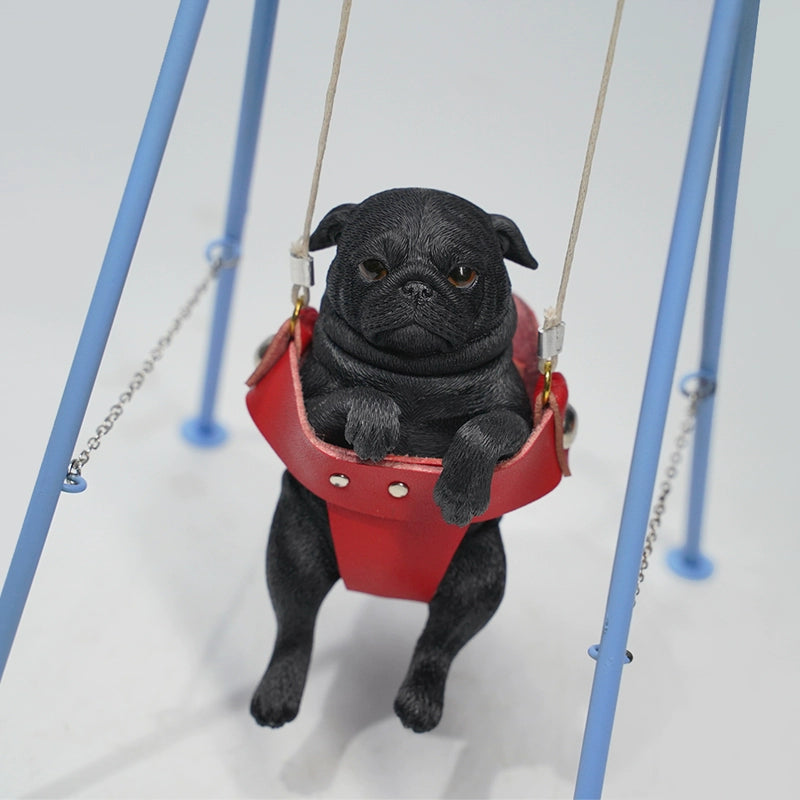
394;520;506;733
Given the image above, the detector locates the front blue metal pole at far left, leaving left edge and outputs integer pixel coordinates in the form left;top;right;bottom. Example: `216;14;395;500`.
0;0;207;677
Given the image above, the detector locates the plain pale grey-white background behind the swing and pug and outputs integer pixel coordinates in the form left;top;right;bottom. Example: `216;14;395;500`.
0;0;800;798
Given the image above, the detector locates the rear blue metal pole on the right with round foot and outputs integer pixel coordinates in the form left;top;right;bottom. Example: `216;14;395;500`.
668;0;759;580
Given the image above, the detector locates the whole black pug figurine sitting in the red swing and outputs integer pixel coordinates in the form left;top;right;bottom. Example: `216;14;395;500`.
251;189;537;732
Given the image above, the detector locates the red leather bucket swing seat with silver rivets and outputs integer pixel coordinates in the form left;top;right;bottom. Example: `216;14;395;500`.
247;297;569;602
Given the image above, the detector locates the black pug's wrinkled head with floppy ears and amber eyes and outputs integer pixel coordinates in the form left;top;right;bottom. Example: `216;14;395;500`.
310;189;537;358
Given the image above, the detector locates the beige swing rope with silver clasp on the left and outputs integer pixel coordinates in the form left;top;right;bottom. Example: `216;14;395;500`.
289;0;353;306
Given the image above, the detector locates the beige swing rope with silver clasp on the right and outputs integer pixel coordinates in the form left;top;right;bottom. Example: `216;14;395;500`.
539;0;625;384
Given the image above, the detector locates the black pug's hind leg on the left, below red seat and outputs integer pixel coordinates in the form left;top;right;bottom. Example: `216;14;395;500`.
250;472;339;728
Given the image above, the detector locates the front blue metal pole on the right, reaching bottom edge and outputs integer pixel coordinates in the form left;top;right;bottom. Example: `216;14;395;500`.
575;0;743;798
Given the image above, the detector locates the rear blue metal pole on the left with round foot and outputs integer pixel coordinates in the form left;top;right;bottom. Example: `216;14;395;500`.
181;0;278;447
